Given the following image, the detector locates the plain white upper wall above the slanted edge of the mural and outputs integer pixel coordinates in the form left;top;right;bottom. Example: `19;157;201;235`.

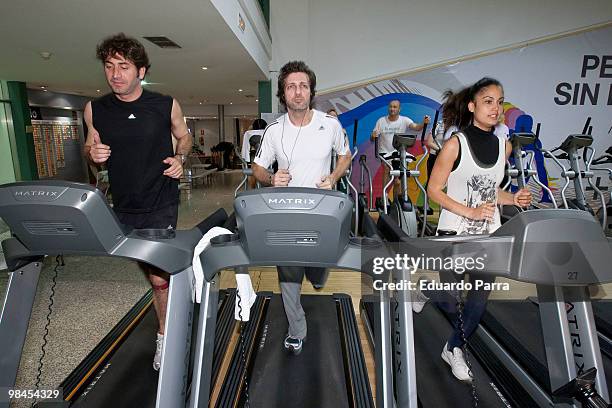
270;0;612;92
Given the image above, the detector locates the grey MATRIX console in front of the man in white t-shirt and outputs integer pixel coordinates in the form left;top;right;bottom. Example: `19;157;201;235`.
234;187;353;263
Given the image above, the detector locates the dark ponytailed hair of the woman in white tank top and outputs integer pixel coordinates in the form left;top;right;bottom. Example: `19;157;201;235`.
442;77;503;129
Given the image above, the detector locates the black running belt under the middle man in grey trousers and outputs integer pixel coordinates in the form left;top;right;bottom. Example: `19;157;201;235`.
248;295;349;408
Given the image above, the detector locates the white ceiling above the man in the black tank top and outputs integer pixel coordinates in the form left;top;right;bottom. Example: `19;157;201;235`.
0;0;266;105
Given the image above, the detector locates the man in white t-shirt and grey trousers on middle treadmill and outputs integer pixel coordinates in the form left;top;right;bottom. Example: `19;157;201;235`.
253;61;351;354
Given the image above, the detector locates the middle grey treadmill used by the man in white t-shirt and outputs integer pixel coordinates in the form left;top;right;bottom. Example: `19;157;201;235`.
191;187;404;407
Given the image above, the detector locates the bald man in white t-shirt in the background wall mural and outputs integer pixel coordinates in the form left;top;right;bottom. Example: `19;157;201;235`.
371;100;428;202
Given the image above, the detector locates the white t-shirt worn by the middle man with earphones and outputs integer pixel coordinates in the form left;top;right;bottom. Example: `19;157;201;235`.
254;110;350;187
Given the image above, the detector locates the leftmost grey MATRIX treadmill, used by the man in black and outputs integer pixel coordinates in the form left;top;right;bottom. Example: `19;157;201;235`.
0;181;227;407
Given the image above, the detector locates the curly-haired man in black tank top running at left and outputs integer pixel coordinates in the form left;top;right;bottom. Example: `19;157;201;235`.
84;34;192;370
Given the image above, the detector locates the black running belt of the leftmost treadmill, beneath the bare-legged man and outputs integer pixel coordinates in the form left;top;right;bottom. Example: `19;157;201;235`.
72;307;158;408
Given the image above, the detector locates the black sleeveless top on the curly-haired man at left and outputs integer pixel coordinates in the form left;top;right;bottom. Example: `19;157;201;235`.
91;90;178;213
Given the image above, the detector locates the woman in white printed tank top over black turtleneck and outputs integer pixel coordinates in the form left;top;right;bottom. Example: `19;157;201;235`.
420;78;531;382
